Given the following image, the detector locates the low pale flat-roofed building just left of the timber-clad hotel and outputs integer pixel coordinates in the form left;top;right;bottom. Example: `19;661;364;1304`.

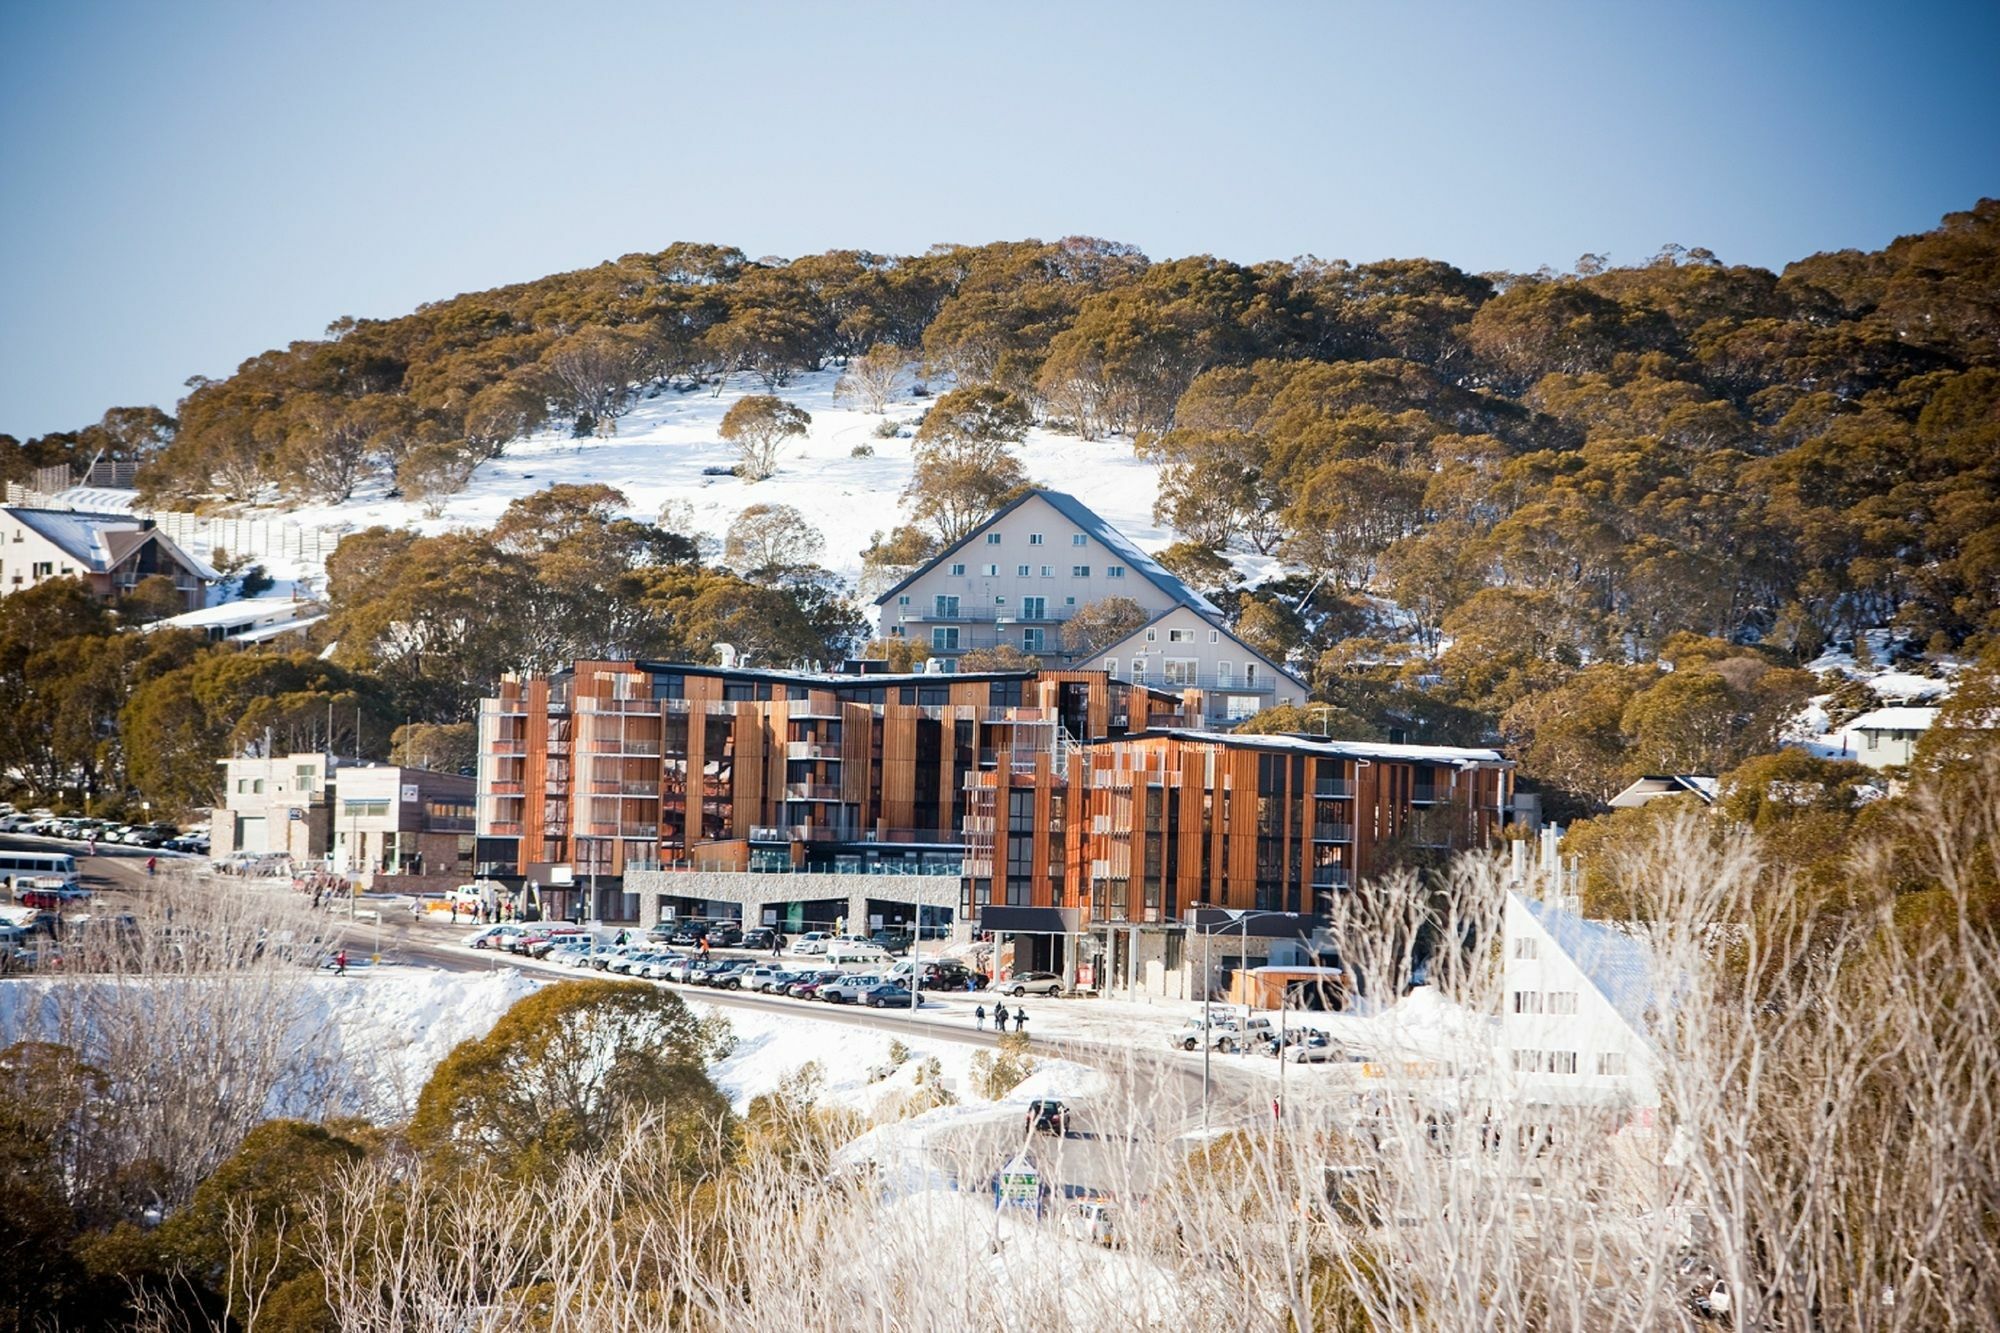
208;753;476;879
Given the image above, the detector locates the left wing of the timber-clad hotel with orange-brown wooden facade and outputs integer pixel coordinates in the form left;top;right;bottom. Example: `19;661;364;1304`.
480;662;1182;877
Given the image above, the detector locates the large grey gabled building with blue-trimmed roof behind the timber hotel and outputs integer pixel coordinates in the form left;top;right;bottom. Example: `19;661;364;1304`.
876;490;1222;675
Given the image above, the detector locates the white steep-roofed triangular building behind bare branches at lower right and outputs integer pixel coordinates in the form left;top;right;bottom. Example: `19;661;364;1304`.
1500;893;1660;1125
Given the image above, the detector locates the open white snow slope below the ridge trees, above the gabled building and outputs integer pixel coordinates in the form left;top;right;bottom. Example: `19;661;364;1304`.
274;370;1174;580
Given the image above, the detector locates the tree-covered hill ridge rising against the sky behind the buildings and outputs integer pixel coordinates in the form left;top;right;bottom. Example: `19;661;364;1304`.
11;200;2000;660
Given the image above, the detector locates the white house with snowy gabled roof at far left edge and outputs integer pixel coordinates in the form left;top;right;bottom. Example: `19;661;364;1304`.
0;504;220;610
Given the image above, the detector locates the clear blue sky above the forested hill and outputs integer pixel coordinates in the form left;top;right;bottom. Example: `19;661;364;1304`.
0;0;2000;438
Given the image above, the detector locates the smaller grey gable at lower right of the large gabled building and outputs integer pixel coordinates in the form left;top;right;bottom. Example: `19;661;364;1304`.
1084;606;1310;727
